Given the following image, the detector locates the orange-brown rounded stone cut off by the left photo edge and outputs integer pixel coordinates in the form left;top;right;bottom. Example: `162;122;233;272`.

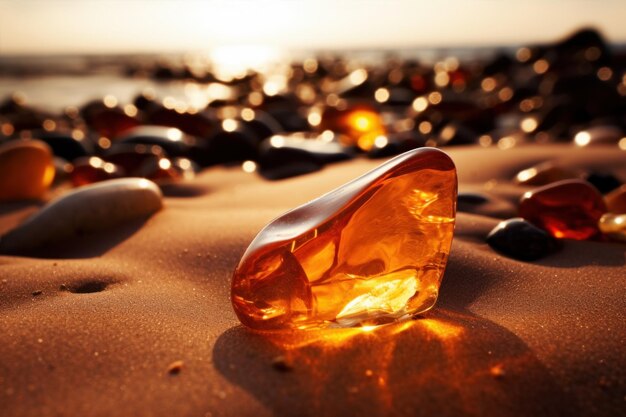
0;140;55;201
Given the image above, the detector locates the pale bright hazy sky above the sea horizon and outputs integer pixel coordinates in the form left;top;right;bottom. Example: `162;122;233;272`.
0;0;626;54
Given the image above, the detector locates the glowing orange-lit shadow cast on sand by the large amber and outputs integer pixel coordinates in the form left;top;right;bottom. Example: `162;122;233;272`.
214;309;574;416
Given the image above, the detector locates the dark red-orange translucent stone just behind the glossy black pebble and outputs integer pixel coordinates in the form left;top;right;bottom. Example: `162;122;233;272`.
519;180;607;240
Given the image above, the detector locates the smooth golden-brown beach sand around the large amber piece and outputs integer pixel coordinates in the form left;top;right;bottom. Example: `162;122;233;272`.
0;145;626;417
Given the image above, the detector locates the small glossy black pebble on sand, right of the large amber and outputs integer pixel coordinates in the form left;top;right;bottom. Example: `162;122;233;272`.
487;217;559;261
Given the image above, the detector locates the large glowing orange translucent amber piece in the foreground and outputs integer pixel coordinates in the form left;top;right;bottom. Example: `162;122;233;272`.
231;148;457;330
